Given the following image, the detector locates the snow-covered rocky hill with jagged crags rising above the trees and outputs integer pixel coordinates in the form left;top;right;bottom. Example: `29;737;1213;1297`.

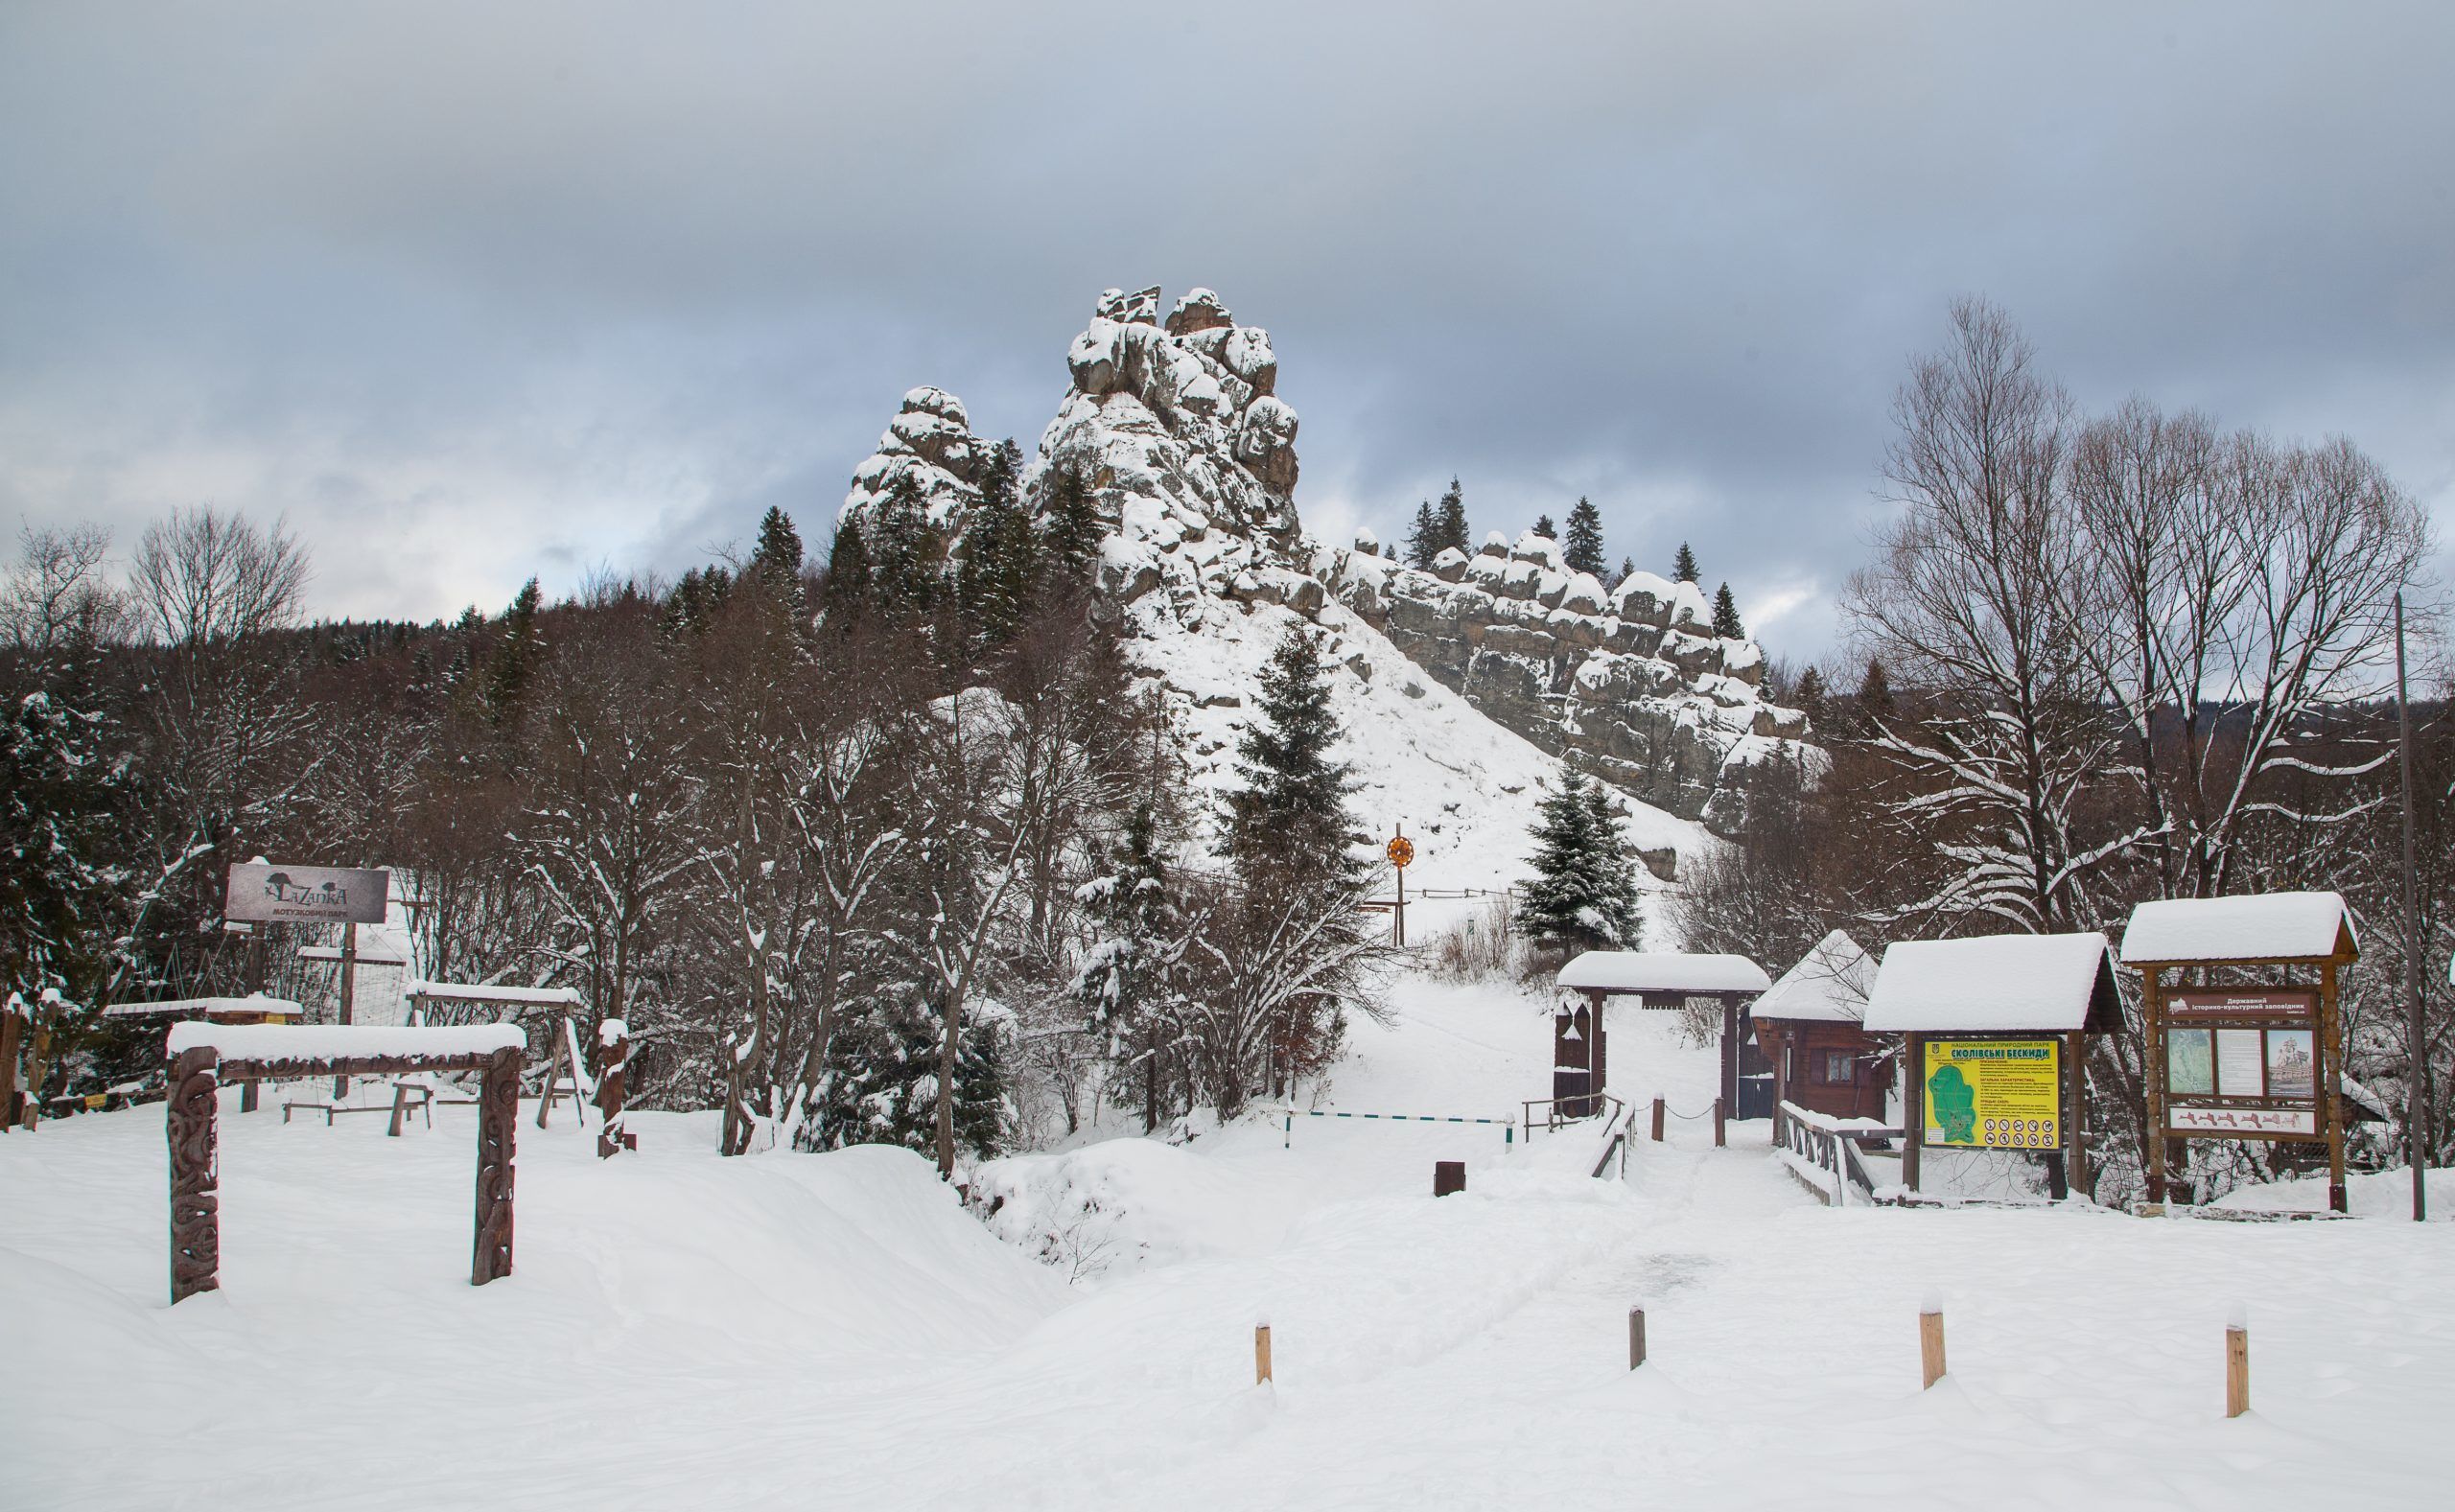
845;290;1805;883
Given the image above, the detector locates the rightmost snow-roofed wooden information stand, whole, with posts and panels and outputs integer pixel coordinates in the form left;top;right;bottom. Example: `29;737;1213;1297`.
2123;894;2362;1213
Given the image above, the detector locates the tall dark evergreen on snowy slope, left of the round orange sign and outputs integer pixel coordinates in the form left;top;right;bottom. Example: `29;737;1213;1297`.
1225;623;1363;881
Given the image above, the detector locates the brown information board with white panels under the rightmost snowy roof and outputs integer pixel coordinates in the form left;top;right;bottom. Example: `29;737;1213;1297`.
2158;987;2323;1141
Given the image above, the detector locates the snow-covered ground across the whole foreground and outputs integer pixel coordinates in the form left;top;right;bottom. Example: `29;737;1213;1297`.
0;982;2455;1512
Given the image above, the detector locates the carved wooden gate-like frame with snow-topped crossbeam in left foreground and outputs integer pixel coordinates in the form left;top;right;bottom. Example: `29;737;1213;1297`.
167;1024;526;1306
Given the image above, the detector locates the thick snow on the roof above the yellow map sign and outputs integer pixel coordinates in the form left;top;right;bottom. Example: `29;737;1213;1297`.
1866;930;2121;1034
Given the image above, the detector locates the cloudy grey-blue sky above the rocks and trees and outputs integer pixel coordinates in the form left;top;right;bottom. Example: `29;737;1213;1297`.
0;0;2455;656
